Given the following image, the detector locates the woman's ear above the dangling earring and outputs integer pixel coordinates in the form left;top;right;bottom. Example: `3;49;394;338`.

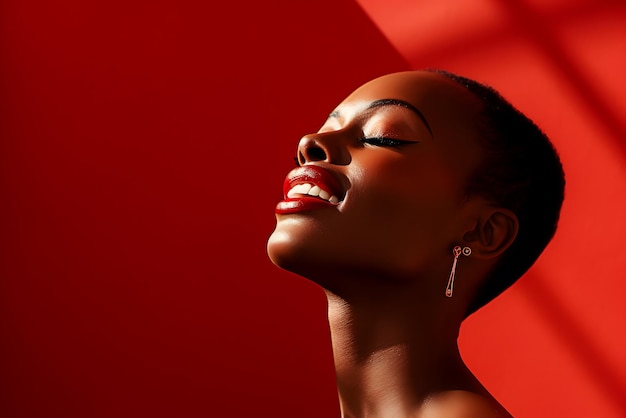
463;207;519;258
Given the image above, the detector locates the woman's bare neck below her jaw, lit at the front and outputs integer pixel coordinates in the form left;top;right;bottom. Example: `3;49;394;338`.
327;291;472;418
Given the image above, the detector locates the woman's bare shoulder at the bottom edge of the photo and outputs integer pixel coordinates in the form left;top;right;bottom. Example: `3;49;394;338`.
419;390;512;418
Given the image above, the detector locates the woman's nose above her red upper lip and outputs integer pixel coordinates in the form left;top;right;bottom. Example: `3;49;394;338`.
296;132;352;165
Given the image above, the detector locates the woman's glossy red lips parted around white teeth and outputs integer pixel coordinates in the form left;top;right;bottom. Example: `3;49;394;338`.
276;165;345;214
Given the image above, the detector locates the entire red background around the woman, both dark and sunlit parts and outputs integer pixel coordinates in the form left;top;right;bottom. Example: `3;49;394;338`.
0;0;626;418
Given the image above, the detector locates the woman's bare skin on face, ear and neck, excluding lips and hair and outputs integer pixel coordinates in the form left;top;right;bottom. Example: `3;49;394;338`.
268;71;518;418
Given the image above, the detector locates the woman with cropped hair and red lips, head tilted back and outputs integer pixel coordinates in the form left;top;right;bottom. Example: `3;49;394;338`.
268;71;564;417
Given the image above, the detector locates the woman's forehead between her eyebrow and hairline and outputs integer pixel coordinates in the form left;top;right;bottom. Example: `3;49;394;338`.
337;71;481;136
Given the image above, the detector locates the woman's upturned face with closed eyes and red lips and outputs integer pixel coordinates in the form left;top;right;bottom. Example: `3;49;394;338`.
268;72;481;290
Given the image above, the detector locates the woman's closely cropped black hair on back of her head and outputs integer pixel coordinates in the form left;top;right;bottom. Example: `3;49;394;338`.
430;70;565;316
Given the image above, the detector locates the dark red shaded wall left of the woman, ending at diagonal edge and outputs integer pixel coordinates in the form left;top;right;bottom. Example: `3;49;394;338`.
0;0;408;418
